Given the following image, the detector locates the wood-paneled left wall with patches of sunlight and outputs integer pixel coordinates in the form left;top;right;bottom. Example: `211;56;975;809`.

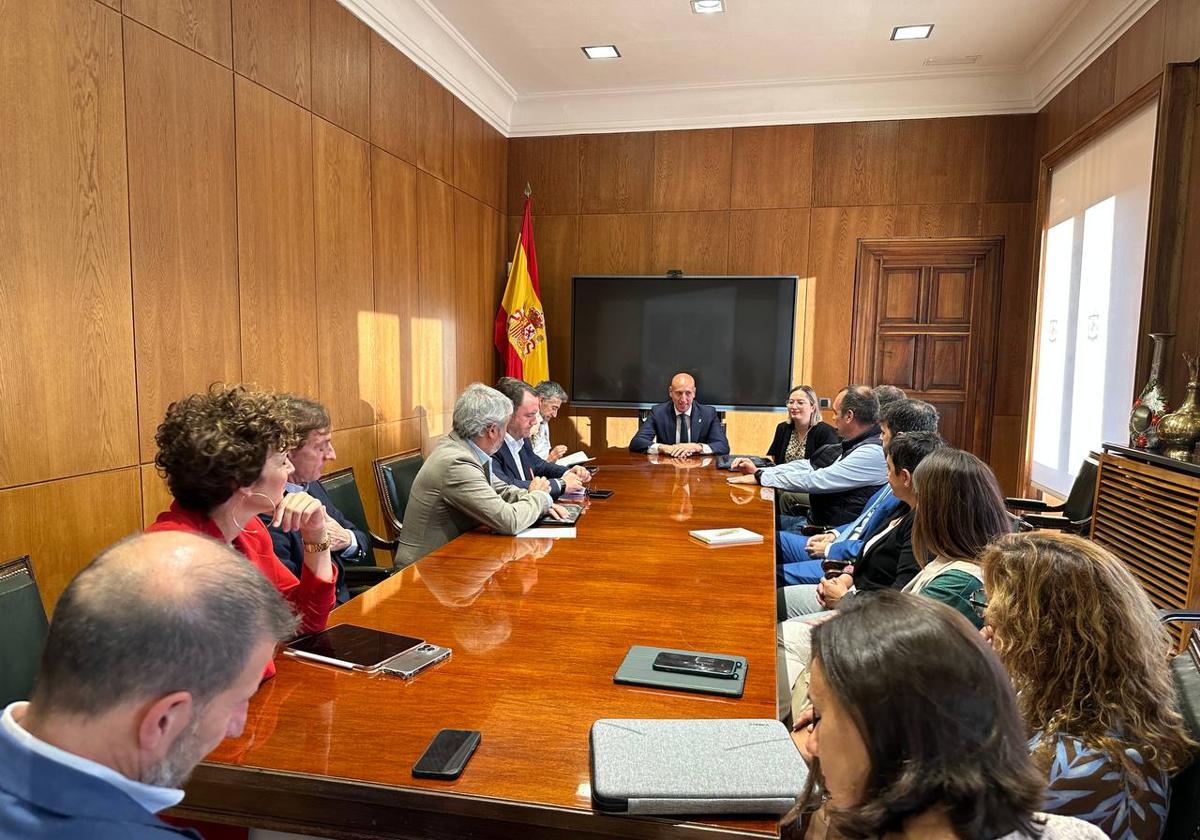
0;0;508;605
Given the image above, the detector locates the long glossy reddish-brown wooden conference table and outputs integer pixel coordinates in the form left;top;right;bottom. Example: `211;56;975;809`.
175;451;779;838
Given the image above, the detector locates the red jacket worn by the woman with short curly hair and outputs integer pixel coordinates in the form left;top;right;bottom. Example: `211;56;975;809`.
146;502;337;679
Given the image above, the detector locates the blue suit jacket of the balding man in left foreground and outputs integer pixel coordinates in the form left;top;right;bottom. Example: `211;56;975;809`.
0;730;200;840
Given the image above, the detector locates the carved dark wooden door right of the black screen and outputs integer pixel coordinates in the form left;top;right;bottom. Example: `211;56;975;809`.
851;238;1003;460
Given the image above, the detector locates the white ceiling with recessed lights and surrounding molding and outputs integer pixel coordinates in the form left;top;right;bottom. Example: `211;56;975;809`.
342;0;1154;136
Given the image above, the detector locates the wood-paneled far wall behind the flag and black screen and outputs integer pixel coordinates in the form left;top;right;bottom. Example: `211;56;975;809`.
508;115;1036;487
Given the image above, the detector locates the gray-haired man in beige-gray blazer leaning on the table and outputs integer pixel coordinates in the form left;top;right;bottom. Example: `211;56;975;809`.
396;382;566;566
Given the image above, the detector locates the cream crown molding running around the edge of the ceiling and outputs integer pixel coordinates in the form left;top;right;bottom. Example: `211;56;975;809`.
340;0;1156;137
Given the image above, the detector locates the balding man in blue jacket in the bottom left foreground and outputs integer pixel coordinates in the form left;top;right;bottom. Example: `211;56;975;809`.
0;532;296;840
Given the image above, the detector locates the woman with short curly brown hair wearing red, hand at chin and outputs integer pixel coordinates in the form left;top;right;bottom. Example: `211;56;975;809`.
146;385;336;677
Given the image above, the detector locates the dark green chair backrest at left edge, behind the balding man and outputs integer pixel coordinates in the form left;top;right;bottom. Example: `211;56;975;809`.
0;556;49;707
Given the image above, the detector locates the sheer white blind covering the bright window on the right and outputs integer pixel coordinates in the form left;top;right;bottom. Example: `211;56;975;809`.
1031;102;1158;497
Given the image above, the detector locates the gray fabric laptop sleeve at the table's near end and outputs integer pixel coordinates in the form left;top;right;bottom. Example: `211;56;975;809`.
590;719;808;815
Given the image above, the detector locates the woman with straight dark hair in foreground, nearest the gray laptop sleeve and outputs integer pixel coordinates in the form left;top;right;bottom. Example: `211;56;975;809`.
793;589;1104;840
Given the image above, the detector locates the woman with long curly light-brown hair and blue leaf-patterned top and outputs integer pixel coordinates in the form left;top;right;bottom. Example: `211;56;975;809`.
980;534;1195;840
